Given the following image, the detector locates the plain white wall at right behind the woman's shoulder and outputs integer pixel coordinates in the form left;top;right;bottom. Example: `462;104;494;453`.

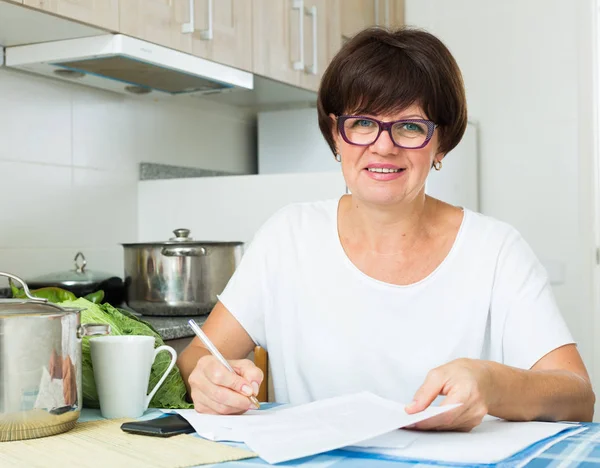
406;0;600;400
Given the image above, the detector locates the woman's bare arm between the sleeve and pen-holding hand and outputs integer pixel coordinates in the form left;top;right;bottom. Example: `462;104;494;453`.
177;302;254;393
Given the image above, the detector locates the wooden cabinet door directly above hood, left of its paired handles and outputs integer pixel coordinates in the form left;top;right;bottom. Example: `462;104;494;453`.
119;0;192;53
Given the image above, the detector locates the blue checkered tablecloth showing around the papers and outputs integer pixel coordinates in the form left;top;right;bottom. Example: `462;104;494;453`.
81;409;600;468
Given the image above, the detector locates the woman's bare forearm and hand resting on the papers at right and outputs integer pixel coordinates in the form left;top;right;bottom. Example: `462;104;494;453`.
407;344;595;430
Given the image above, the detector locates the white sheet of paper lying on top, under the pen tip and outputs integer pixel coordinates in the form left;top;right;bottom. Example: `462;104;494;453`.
173;392;459;463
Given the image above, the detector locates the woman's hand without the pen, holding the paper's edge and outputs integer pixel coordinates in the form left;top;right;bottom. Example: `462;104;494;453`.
406;359;495;431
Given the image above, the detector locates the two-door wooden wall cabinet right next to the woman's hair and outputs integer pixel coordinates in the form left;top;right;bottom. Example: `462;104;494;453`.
252;0;341;91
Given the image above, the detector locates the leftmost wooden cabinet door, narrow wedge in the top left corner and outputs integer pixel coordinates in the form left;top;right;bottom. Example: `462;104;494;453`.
23;0;119;32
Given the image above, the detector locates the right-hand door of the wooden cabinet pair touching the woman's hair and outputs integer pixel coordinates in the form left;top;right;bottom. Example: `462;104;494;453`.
300;0;343;91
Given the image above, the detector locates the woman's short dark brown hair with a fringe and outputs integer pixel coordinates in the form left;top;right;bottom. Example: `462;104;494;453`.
317;27;467;154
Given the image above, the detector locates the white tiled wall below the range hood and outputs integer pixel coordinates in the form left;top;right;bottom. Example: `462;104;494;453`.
0;69;256;285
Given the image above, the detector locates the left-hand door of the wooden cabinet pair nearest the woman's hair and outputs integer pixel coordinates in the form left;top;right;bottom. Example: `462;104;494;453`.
252;0;304;86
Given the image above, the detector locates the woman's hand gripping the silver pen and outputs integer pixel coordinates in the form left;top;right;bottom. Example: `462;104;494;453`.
189;355;263;414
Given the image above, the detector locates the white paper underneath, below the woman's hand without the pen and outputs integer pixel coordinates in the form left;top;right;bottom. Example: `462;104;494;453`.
348;417;584;464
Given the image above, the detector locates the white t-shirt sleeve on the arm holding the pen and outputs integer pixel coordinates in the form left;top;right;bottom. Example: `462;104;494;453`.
217;208;285;349
